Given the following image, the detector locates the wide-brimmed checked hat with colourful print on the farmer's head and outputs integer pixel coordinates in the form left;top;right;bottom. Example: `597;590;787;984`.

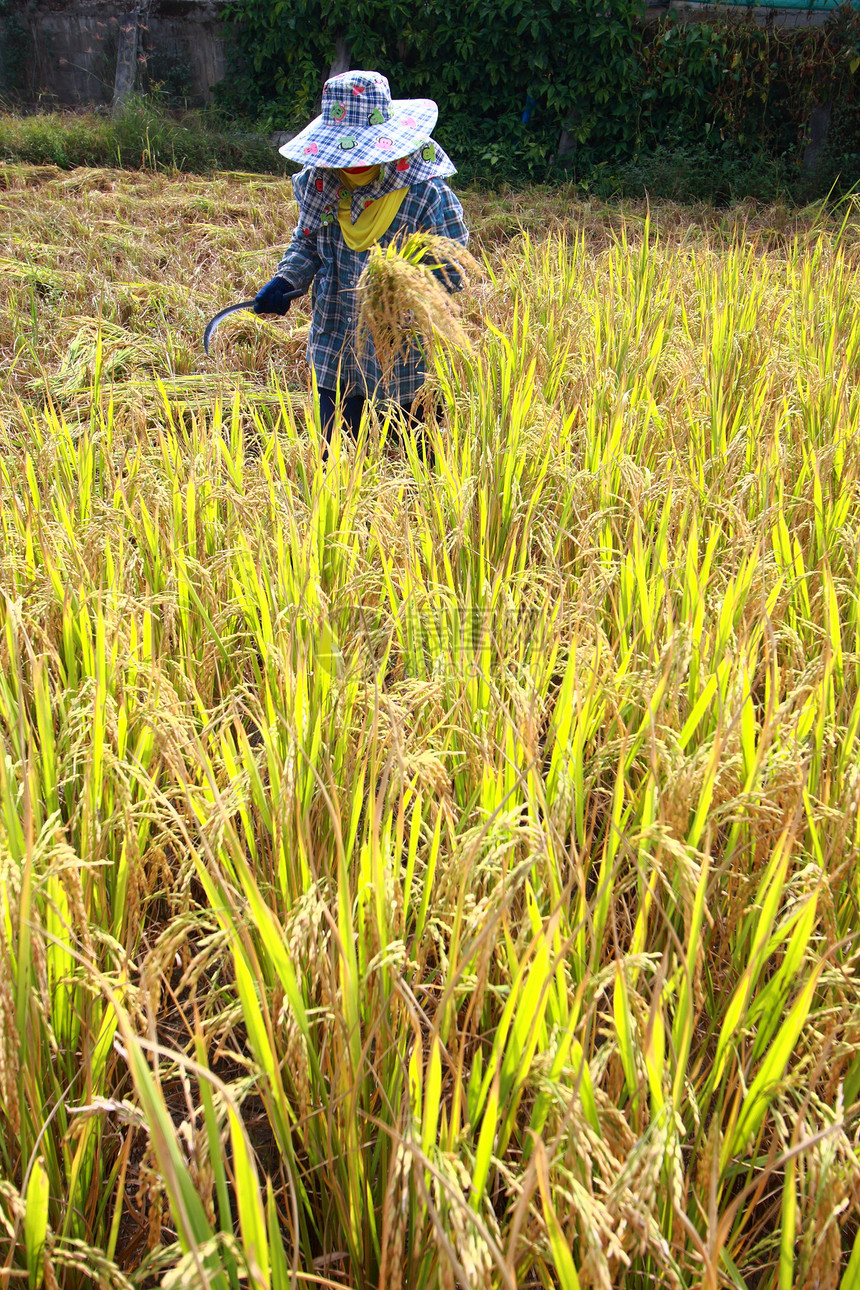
279;71;438;169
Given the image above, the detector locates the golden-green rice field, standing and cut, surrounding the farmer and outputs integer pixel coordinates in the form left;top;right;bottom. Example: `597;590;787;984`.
0;165;860;1290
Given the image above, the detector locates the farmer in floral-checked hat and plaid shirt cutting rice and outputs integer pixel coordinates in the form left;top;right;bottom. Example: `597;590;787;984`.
254;71;469;453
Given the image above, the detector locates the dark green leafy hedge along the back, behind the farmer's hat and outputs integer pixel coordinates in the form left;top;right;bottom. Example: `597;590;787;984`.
219;0;860;200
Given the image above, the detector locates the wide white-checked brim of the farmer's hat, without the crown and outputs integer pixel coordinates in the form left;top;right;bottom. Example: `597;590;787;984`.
277;98;438;169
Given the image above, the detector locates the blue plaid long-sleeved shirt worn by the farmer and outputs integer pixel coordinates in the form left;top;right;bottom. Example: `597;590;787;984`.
277;179;469;404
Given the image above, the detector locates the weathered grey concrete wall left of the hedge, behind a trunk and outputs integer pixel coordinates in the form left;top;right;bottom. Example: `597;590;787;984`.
0;0;226;107
